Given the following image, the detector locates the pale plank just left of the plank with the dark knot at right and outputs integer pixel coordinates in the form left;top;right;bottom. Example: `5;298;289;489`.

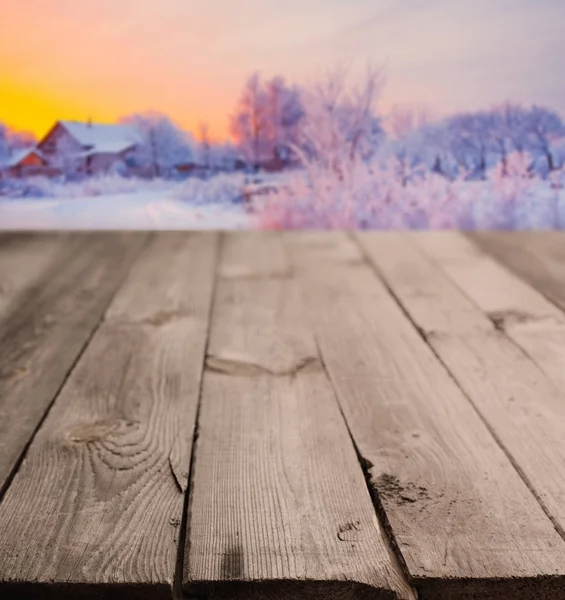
361;233;565;537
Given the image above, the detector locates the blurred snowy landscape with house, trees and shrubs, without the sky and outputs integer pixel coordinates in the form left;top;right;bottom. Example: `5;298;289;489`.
0;67;565;229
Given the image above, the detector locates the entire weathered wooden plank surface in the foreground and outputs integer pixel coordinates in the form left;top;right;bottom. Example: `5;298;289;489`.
0;232;565;600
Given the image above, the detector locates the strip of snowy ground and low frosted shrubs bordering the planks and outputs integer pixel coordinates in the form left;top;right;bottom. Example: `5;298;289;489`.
0;164;565;230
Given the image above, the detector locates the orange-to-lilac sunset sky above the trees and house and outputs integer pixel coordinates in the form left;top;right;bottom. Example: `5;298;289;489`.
0;0;565;137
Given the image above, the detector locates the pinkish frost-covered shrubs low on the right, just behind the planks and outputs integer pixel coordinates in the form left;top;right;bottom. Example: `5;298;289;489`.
253;155;565;229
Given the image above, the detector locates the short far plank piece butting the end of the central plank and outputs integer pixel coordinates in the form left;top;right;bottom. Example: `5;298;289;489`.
219;231;290;279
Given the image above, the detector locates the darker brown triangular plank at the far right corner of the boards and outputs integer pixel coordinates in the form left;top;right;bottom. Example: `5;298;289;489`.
468;231;565;310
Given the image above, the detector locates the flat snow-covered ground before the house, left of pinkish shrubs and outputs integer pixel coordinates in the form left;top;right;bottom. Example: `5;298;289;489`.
0;178;249;229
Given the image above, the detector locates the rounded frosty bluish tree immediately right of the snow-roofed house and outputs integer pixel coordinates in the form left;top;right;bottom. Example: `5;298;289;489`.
122;112;196;177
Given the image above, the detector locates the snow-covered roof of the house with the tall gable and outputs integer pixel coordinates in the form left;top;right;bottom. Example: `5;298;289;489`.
59;121;141;154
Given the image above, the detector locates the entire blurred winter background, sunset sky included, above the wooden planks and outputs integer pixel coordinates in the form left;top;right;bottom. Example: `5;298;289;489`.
0;0;565;230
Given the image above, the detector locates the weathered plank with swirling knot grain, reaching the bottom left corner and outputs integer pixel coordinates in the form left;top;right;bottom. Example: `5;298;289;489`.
0;234;217;599
